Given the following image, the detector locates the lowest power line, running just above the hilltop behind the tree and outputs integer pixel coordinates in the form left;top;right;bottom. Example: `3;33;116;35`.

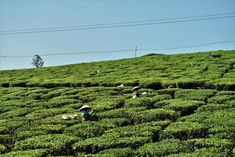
0;40;235;58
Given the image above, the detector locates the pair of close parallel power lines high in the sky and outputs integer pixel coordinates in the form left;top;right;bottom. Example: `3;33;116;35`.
0;13;235;35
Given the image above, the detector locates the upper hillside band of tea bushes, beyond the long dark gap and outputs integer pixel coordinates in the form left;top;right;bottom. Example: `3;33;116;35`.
0;50;235;90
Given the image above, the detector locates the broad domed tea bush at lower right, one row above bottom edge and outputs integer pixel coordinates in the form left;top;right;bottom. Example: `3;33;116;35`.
161;122;208;139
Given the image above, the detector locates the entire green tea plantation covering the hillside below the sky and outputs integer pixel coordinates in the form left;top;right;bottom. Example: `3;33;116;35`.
0;50;235;157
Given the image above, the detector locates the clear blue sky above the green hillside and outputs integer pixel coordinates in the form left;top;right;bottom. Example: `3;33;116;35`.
0;0;235;70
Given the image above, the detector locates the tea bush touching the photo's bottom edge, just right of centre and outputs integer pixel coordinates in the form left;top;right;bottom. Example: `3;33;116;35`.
137;139;188;157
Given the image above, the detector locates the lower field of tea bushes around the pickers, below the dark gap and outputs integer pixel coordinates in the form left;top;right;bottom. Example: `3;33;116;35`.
0;86;235;157
